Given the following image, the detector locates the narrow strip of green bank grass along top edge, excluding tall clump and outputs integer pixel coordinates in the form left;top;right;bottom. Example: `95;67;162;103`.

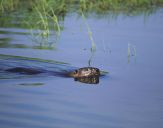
0;0;163;15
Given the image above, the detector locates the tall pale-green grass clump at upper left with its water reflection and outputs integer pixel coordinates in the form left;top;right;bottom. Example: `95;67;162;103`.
27;0;61;48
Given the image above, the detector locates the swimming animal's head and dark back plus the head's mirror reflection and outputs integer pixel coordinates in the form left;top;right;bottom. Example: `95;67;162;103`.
5;67;100;84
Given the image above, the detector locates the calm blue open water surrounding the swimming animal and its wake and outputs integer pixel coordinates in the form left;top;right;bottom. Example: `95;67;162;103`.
0;9;163;128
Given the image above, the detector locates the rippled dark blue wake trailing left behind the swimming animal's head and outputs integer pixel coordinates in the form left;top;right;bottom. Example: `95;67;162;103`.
0;54;76;79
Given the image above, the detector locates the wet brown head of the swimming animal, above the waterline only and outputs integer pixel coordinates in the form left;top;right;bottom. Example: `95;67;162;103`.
69;67;100;78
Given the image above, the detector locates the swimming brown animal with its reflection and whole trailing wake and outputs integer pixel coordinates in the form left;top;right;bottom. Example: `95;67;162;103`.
0;54;107;84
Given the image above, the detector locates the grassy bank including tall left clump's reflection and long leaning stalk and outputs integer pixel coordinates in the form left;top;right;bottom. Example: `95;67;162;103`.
0;0;163;49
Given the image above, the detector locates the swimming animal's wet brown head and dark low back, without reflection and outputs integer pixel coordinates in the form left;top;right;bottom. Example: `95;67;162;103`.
6;67;100;78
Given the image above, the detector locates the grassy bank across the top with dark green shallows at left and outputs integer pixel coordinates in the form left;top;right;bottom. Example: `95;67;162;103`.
0;0;163;27
